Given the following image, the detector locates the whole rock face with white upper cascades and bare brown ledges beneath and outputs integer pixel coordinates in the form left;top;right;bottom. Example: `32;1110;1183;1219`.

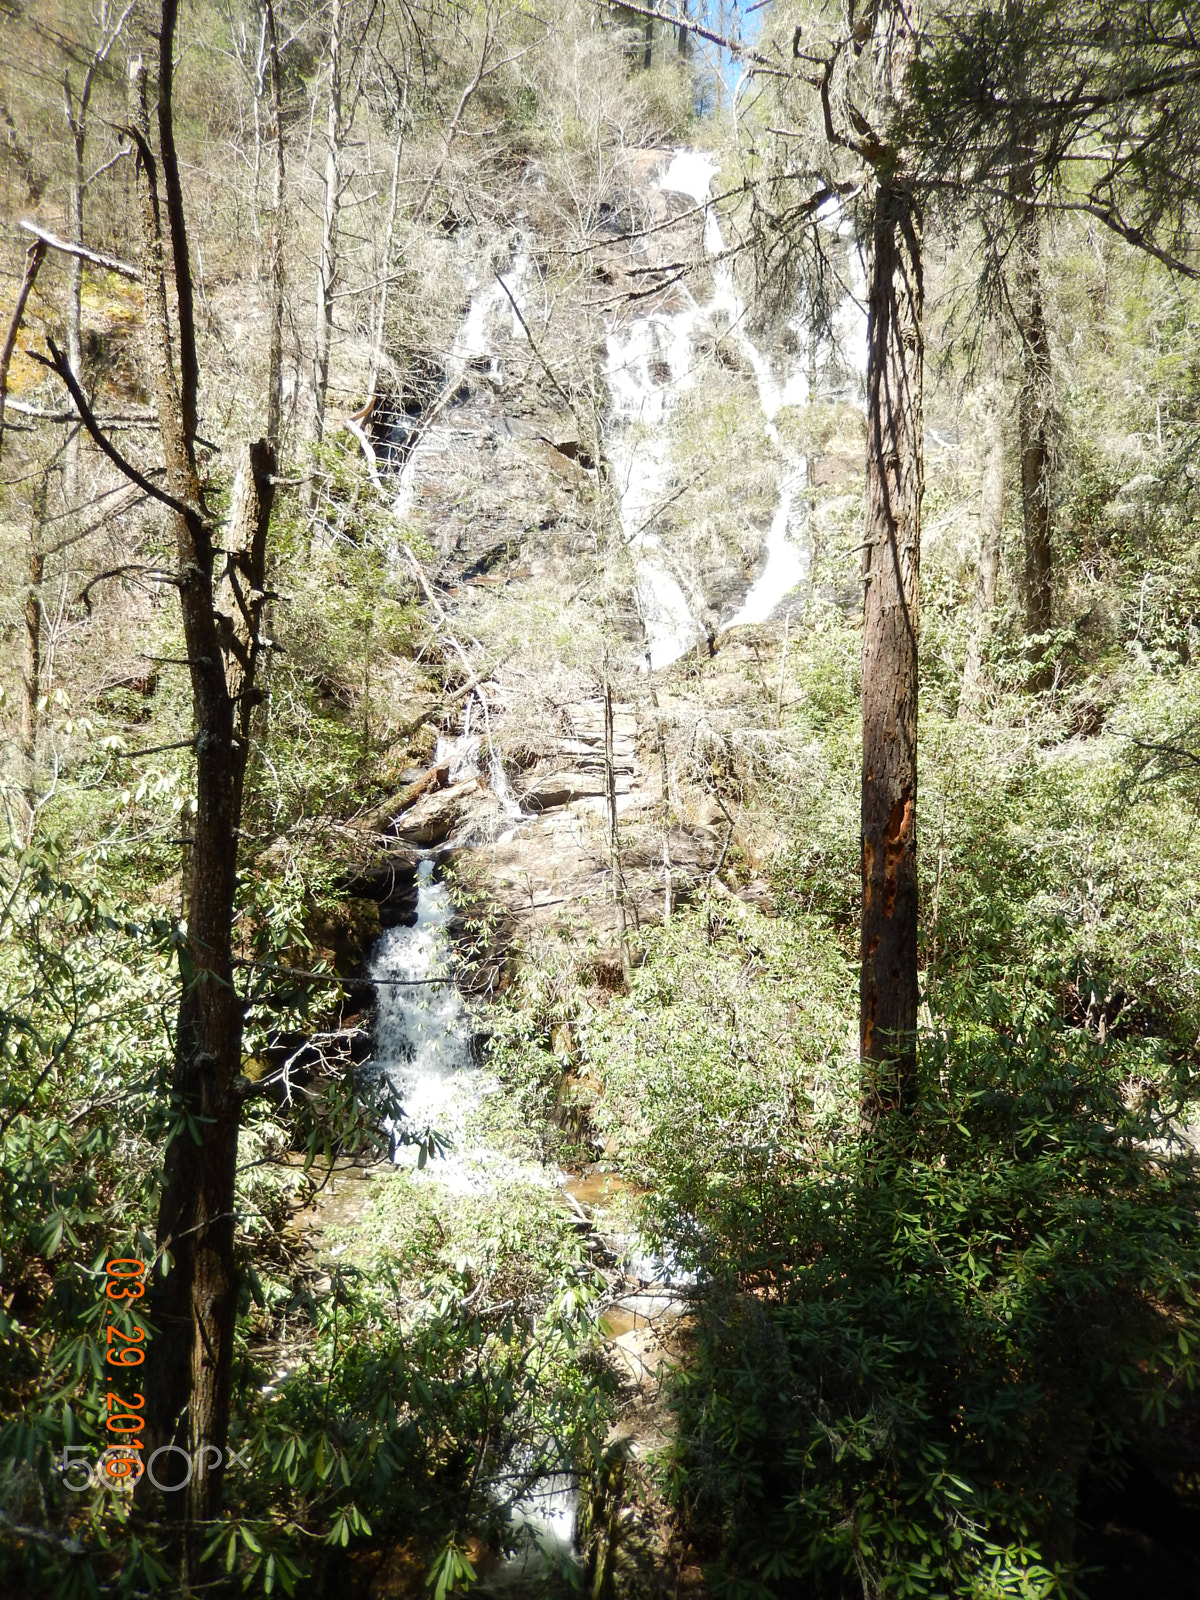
345;140;862;947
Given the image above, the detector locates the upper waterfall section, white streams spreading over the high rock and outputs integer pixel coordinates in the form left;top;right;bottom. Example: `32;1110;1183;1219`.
382;149;864;669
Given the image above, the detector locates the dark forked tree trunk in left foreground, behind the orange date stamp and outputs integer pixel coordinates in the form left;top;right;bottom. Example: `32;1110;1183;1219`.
121;21;274;1561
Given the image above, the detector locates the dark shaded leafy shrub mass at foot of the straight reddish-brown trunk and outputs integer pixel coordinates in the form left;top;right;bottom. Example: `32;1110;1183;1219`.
672;1026;1200;1597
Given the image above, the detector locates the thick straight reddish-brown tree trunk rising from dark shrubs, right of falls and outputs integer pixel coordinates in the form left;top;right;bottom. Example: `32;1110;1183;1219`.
859;5;925;1128
